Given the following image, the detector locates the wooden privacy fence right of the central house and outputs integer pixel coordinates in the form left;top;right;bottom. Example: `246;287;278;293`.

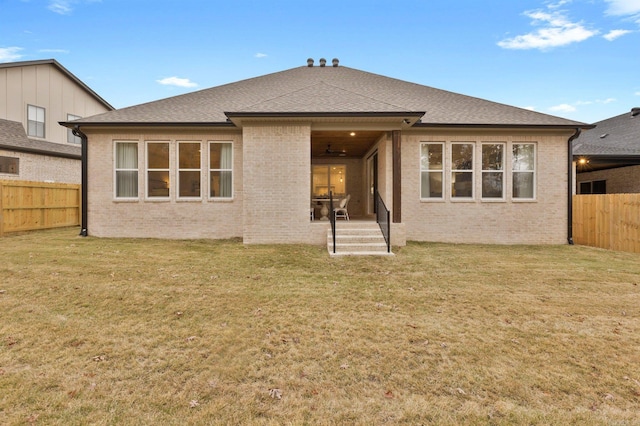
573;194;640;253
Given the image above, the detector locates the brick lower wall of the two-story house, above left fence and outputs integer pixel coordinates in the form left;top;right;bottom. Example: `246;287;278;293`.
0;150;82;184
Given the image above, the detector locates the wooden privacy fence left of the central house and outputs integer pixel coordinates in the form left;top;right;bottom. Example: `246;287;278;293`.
0;180;81;237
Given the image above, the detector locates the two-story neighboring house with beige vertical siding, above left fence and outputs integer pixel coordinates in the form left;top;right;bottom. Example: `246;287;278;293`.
0;59;113;183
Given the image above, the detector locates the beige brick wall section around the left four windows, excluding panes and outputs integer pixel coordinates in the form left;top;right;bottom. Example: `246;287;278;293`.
87;129;243;239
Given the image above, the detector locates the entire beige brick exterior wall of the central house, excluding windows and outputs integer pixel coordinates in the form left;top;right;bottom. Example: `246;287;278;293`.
87;123;571;245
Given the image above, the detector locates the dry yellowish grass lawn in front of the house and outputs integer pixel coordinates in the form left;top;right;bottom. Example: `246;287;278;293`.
0;229;640;425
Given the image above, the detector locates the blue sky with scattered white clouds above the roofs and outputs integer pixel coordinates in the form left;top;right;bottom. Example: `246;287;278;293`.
0;0;640;123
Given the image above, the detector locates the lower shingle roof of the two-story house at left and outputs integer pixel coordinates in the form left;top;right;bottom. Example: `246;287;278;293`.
0;119;81;159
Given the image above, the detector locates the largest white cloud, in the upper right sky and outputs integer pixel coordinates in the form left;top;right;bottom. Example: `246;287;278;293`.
498;7;598;50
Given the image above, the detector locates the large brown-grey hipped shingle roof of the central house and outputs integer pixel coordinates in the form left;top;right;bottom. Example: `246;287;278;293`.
66;62;589;128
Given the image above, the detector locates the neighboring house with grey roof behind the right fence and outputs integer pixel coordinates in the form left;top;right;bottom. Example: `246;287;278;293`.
573;108;640;194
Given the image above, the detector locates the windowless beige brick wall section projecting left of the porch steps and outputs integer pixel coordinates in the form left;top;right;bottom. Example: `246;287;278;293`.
243;123;311;244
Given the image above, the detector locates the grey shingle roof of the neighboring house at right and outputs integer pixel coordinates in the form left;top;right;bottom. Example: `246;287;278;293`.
573;108;640;156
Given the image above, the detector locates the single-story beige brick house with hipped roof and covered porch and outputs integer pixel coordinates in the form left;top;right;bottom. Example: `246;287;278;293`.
63;59;590;245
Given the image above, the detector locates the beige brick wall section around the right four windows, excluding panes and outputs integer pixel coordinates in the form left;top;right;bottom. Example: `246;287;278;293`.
402;130;570;244
